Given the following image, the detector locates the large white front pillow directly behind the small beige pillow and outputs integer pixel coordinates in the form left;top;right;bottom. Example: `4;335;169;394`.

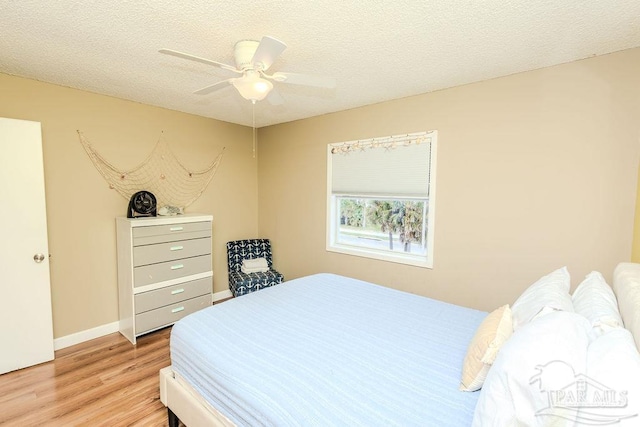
473;311;591;427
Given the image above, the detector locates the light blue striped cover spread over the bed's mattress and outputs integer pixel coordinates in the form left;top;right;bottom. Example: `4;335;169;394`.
170;274;487;426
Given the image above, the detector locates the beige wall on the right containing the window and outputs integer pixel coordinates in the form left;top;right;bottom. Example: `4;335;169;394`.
258;49;640;310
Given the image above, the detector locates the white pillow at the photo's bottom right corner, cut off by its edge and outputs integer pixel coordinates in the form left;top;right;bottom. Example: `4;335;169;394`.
580;328;640;426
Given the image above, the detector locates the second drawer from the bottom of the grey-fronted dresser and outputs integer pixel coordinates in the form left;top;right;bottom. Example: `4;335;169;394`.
134;277;212;314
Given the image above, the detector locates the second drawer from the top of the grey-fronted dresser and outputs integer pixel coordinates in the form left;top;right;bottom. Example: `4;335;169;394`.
133;237;211;267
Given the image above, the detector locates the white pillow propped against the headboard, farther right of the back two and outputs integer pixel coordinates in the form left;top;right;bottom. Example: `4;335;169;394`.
571;271;623;336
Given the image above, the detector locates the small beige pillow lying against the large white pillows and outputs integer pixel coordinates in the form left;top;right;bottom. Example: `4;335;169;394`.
460;304;513;391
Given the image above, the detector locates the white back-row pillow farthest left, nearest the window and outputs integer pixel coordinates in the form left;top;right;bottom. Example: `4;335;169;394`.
511;267;574;331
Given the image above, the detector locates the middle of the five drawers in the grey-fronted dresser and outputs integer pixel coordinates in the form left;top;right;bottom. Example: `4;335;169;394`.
133;255;211;287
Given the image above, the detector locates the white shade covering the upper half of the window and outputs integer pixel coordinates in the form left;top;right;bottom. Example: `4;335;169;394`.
329;132;431;198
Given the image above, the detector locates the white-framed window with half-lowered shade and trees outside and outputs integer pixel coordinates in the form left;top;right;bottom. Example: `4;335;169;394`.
327;131;437;268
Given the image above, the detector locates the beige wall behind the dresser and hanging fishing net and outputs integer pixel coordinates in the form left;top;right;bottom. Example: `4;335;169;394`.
0;74;258;337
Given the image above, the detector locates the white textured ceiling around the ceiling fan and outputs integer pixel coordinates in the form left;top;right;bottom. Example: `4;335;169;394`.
0;0;640;127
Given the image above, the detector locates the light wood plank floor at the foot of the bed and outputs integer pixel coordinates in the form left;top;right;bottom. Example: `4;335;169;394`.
0;328;171;427
